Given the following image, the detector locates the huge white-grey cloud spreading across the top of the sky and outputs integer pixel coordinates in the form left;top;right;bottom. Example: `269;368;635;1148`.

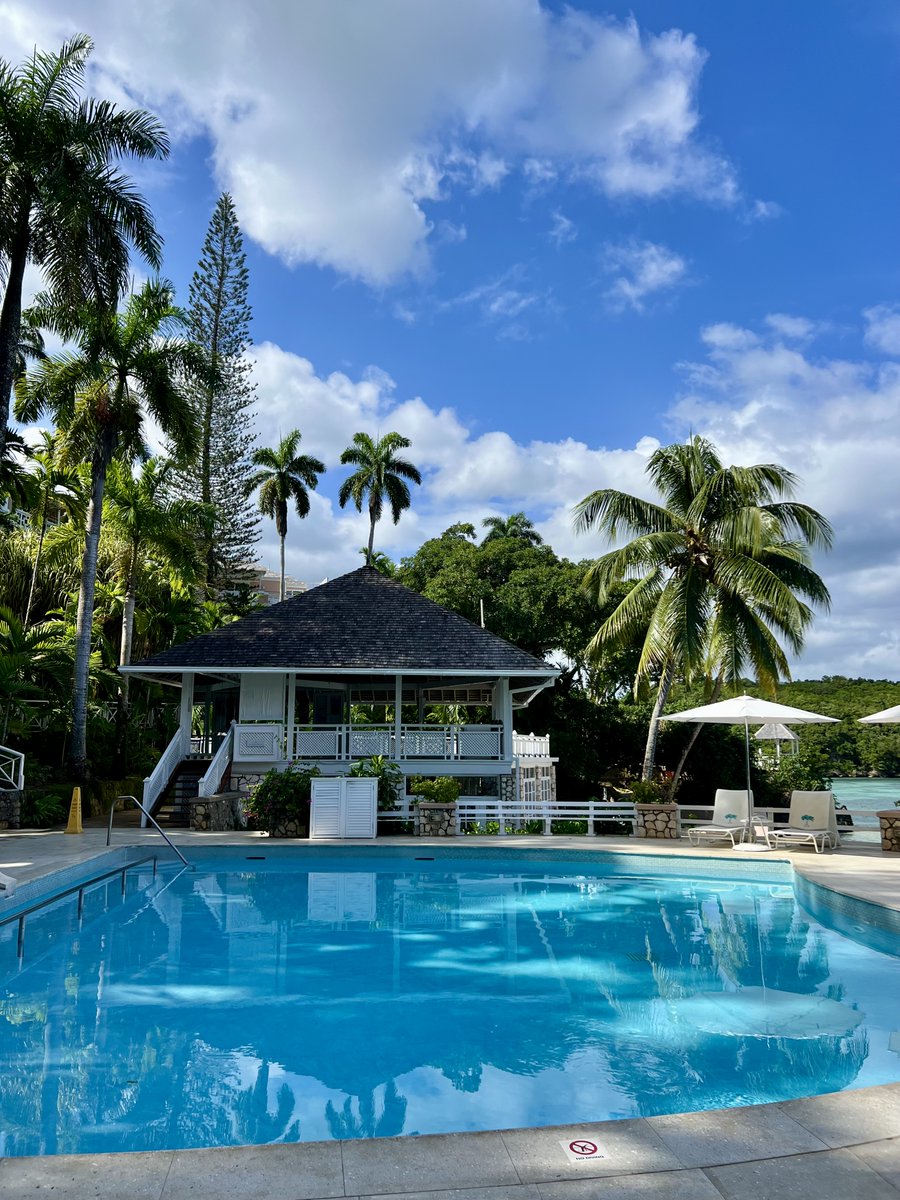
4;0;739;284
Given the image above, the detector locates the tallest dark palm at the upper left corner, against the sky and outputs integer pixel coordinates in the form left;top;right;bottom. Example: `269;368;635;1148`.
0;34;169;443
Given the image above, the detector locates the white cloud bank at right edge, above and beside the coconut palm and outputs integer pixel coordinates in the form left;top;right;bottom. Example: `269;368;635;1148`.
670;319;900;678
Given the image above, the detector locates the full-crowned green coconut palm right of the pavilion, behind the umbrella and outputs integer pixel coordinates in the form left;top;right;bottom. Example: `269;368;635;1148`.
575;436;832;779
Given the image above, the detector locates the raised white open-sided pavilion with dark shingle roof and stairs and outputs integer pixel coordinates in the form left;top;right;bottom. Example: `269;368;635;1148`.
121;566;559;810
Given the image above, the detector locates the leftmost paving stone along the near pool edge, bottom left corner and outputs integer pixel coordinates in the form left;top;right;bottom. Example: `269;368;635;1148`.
0;1151;174;1200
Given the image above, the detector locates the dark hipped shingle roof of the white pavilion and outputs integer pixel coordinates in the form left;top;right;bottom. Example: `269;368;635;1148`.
132;566;556;677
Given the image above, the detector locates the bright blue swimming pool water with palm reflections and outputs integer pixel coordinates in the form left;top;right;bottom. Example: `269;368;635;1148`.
0;851;900;1154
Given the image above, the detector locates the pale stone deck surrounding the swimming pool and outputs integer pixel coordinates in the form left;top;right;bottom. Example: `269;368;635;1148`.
0;827;900;1200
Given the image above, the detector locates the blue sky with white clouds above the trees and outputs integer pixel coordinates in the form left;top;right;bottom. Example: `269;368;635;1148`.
10;0;900;677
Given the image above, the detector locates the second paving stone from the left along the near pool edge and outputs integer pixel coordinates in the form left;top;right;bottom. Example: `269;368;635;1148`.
162;1141;344;1200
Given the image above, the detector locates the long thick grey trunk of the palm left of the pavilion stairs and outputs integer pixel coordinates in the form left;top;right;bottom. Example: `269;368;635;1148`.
68;426;115;781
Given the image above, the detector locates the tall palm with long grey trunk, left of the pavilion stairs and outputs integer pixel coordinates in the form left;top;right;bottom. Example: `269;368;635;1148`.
17;281;203;779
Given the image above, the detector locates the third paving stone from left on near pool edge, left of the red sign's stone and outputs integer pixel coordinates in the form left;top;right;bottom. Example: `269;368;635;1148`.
340;1133;520;1200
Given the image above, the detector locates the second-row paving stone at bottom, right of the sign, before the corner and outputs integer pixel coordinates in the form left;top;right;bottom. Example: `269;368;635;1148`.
706;1150;898;1200
